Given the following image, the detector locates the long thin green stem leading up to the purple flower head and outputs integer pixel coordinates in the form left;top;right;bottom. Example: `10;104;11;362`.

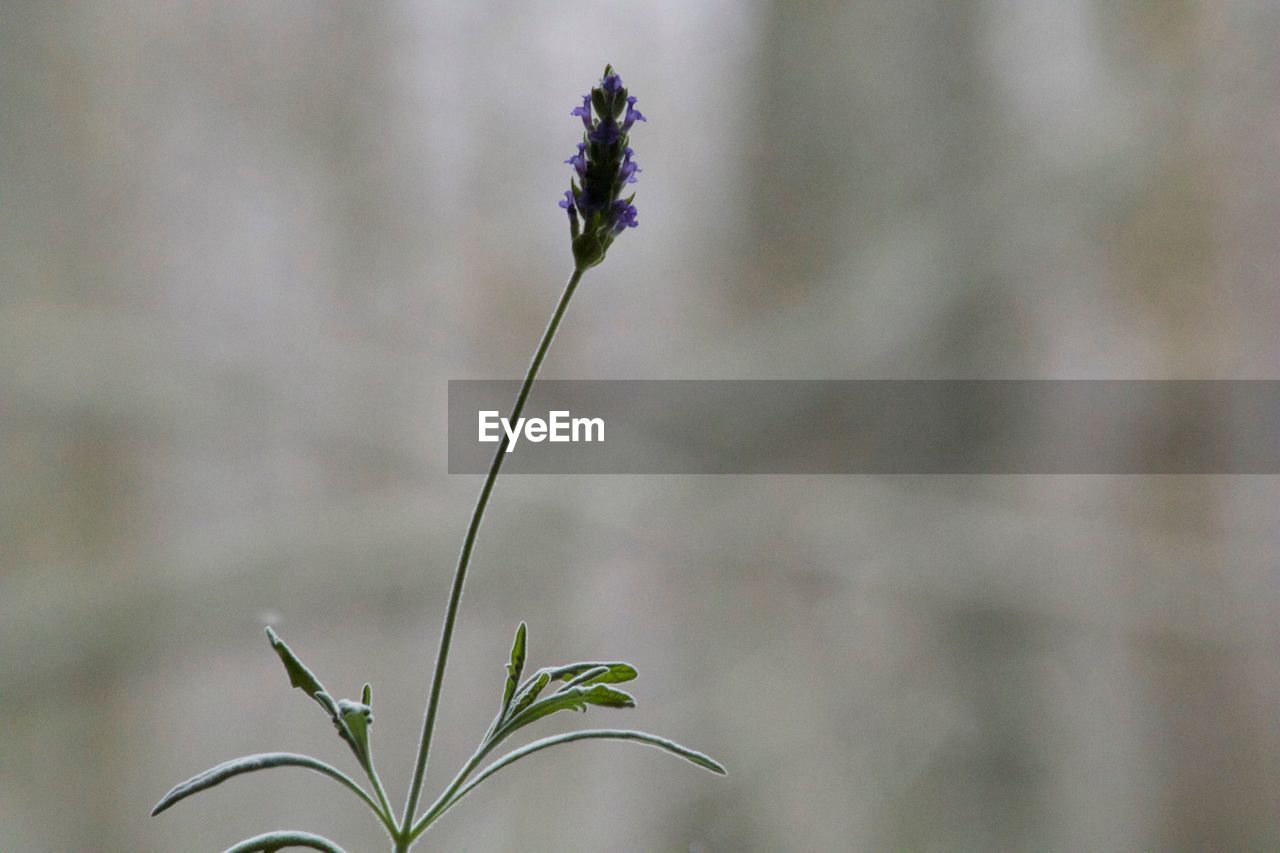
396;268;585;835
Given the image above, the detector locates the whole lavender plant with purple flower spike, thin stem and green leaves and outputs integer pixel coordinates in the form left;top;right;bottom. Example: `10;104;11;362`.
151;67;724;853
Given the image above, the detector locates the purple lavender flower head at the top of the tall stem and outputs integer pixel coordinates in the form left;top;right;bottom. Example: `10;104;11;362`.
559;65;648;269
